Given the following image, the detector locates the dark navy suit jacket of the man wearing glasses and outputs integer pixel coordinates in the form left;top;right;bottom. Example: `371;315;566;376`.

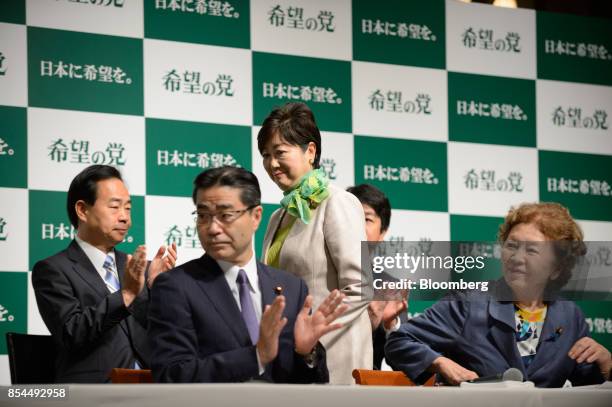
149;255;329;383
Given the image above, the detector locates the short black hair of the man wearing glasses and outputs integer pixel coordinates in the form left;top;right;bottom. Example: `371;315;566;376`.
192;166;261;206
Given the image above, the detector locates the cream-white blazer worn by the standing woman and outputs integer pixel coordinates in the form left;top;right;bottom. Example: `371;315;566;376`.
262;185;372;384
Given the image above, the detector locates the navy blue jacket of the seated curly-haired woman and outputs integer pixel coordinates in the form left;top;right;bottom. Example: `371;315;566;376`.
385;280;604;387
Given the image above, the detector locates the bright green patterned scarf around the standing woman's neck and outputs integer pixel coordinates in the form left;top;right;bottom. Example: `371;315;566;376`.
281;168;329;224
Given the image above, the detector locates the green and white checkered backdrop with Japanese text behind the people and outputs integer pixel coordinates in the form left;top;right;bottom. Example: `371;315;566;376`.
0;0;612;384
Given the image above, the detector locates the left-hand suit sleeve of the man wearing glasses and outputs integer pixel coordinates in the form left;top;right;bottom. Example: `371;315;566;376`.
149;272;259;383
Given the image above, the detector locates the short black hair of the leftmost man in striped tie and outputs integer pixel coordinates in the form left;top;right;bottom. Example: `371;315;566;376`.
66;165;123;228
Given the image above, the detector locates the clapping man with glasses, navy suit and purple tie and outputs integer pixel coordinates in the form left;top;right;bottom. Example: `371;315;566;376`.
149;167;346;383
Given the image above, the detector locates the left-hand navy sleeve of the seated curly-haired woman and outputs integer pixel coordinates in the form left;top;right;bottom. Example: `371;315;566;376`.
385;294;469;384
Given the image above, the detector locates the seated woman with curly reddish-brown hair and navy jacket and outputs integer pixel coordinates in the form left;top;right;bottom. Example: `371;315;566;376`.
385;203;612;387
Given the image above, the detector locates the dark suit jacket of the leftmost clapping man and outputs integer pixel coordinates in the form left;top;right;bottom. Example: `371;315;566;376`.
32;241;150;383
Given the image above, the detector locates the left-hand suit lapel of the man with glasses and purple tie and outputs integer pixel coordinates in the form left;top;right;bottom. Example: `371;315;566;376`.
196;254;251;345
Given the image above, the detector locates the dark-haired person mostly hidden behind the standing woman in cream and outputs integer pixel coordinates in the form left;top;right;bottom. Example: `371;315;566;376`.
347;184;408;370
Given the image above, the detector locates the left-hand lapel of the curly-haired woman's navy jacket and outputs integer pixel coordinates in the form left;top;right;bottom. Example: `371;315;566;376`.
489;300;525;376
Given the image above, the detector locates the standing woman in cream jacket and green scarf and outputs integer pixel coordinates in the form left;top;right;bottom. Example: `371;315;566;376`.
257;103;372;384
